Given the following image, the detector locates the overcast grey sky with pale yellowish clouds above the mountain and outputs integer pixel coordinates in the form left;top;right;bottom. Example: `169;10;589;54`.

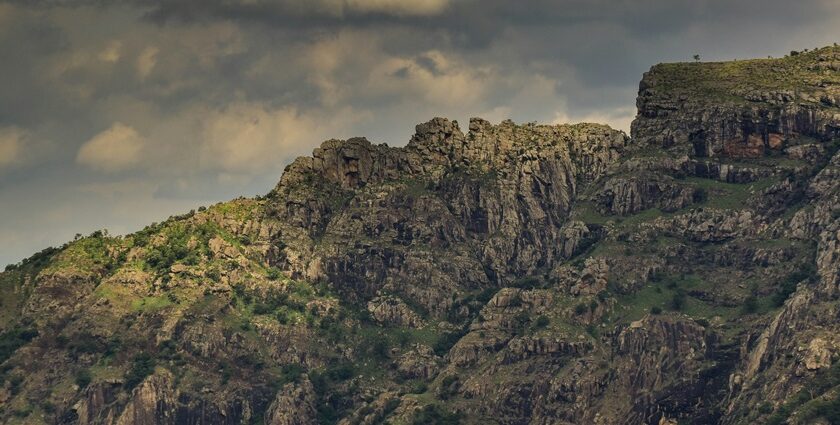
0;0;840;266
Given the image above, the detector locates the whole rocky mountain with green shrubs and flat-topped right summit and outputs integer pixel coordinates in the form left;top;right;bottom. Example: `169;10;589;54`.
0;46;840;425
